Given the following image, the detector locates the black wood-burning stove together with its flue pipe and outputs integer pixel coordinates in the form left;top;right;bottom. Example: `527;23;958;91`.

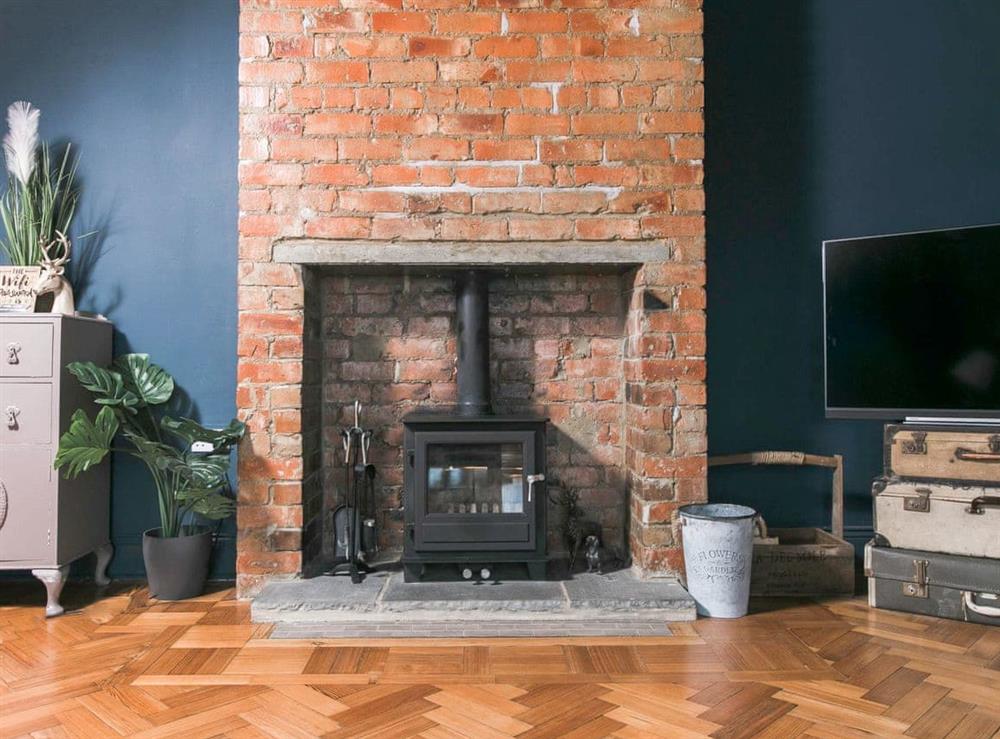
403;271;547;582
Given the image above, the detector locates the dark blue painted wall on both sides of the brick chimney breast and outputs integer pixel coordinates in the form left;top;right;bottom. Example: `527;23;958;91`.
0;0;1000;575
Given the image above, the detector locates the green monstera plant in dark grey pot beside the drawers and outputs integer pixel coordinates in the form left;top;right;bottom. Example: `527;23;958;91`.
55;354;245;600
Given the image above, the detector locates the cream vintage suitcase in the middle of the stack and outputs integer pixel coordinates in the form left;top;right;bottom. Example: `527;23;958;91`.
872;477;1000;559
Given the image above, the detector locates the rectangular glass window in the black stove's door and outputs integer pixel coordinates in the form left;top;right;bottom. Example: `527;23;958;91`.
427;444;524;515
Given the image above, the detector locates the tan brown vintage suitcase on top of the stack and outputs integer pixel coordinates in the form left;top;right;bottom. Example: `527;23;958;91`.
885;424;1000;485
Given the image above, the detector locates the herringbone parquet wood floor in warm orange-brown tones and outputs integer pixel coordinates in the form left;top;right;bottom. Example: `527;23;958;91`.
0;584;1000;739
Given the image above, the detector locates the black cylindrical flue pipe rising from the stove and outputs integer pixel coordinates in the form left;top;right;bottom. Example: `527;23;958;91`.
455;270;493;416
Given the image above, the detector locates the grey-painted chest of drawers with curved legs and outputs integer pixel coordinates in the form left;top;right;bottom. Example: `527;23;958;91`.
0;313;112;616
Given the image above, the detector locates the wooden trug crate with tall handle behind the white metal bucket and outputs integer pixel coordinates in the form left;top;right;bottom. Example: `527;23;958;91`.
708;452;854;596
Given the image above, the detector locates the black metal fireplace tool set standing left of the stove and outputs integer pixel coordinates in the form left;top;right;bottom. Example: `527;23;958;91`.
326;401;378;584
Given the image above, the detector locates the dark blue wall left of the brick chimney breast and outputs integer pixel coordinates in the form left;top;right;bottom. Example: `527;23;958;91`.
0;0;238;576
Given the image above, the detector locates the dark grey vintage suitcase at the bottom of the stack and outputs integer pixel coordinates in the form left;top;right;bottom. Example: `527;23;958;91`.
865;540;1000;626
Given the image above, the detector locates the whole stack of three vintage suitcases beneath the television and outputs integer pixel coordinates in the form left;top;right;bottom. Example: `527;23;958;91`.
865;424;1000;625
